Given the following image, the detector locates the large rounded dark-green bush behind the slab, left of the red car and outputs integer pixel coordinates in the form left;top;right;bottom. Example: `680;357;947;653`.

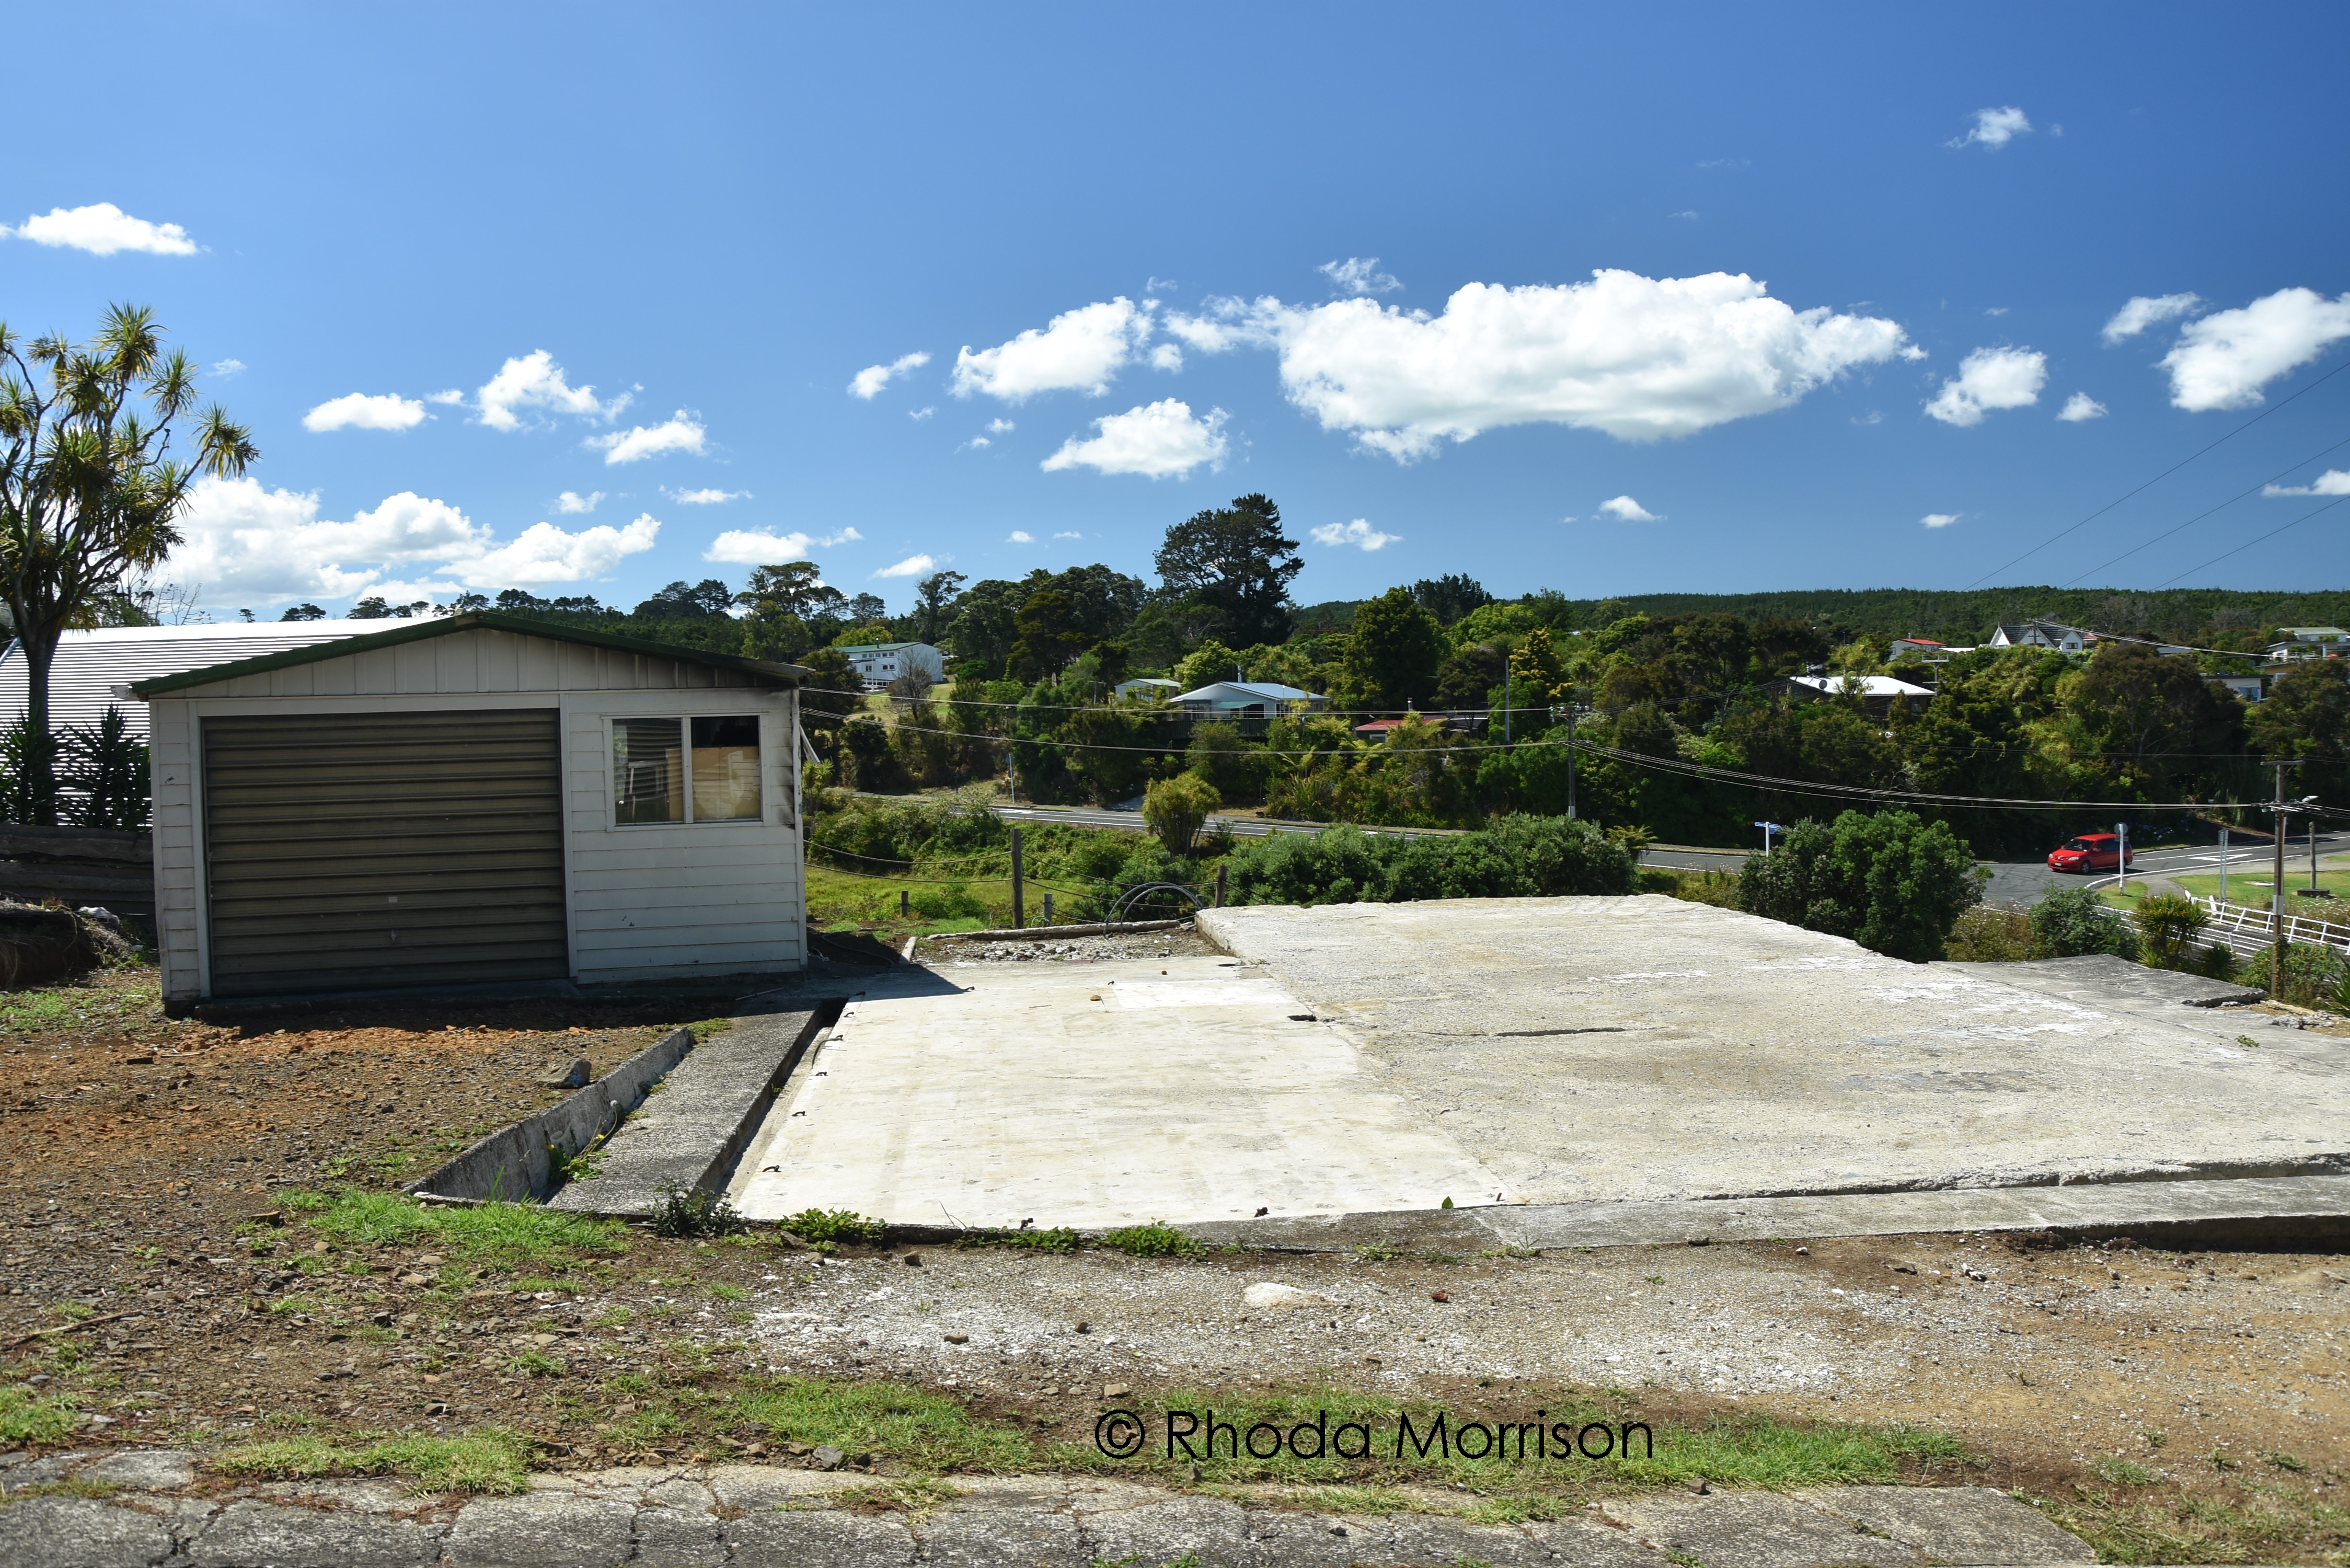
1739;811;1984;964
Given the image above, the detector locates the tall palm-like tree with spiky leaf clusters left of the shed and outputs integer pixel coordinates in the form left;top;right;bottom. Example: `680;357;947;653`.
0;306;261;823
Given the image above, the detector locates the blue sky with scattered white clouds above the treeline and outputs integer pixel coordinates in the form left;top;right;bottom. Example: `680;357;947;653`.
0;2;2350;618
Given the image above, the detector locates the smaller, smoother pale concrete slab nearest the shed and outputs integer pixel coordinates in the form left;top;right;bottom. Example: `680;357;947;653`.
728;957;1502;1229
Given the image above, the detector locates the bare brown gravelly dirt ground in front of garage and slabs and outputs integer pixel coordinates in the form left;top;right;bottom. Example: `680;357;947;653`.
0;964;2350;1563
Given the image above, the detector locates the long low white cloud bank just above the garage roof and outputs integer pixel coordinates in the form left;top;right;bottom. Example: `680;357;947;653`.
169;477;660;604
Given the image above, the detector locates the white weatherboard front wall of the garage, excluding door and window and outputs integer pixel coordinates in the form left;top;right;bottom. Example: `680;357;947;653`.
151;628;806;1001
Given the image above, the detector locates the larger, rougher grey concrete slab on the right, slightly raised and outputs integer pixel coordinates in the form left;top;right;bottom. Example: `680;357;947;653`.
1203;896;2350;1203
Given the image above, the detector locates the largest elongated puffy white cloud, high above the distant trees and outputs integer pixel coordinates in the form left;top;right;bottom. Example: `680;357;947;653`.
1240;270;1906;461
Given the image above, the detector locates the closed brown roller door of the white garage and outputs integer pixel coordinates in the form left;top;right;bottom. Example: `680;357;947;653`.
202;708;571;997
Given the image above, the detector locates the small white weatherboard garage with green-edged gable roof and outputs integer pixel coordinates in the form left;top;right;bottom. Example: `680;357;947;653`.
132;611;806;1009
